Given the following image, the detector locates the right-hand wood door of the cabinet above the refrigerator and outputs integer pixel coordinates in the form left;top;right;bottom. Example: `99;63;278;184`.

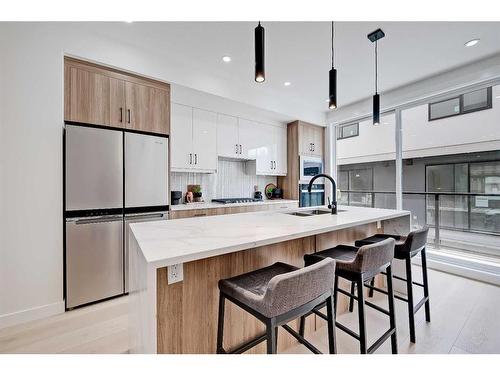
125;81;170;134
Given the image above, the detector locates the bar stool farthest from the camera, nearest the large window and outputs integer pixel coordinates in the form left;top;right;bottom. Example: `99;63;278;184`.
351;226;431;343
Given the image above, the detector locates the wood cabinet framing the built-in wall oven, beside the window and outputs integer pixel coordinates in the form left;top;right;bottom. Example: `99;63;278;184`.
278;121;325;200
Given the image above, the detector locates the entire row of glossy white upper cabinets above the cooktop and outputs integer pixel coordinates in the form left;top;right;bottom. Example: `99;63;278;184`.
170;103;287;176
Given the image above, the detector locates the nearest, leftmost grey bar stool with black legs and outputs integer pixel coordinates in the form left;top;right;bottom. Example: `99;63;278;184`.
217;259;336;354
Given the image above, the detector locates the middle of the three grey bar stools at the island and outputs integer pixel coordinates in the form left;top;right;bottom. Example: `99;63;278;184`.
299;239;398;354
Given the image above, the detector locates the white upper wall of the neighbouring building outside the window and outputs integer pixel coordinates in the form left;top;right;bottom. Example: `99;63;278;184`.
337;86;500;164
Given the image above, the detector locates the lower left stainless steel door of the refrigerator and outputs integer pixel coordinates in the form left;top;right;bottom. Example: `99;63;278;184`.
66;216;124;308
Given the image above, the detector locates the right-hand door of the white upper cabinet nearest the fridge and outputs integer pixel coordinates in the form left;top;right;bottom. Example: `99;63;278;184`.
192;108;217;171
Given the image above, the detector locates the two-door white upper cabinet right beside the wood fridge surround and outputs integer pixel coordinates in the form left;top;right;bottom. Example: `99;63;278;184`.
170;103;217;173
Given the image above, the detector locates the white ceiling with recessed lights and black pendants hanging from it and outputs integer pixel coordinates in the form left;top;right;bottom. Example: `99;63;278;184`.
83;22;500;123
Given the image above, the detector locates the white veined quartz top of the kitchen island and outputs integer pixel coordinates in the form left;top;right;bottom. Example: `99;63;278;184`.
130;206;410;268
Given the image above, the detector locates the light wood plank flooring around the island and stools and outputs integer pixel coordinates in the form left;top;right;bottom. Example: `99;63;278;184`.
0;267;500;354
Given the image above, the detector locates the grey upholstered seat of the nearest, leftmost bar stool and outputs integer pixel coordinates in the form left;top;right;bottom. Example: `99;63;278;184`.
219;262;299;318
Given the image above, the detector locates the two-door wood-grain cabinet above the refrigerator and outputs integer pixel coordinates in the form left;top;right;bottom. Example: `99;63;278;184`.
64;57;170;134
